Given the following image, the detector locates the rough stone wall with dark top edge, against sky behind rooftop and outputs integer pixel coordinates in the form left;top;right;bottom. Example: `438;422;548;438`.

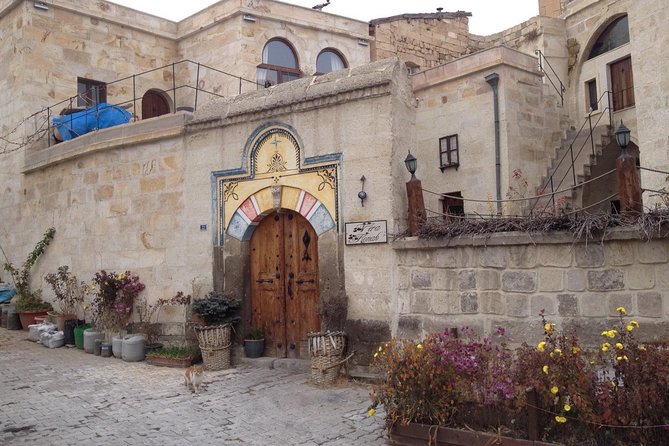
369;12;471;70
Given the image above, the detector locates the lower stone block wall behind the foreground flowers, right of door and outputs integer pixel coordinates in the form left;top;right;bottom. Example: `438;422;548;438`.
394;230;669;345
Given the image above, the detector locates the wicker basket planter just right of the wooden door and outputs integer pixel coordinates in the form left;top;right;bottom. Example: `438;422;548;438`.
307;331;346;386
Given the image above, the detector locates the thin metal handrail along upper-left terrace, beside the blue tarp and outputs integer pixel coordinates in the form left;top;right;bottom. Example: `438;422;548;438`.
24;59;262;147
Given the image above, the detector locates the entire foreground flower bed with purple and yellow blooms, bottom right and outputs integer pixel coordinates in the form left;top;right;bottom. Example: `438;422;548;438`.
368;307;669;446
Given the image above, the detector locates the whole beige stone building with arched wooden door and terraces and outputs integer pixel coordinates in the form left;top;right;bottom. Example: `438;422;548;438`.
0;0;669;362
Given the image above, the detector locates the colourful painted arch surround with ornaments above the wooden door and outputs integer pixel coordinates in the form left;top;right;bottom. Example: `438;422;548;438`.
213;122;341;245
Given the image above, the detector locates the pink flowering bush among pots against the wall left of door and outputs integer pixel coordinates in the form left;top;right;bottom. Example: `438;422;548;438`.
92;270;144;330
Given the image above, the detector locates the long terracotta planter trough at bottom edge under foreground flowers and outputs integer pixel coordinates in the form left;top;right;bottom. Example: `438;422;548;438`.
390;423;556;446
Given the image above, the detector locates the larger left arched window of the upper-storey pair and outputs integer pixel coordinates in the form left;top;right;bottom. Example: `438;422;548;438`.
258;39;302;87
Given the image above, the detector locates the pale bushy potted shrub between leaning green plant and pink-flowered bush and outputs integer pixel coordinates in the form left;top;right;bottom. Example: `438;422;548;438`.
44;265;88;332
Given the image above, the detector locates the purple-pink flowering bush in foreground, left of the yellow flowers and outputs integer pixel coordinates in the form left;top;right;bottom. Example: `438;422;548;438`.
369;327;517;427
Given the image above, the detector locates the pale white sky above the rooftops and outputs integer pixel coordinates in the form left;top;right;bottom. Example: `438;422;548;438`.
111;0;539;35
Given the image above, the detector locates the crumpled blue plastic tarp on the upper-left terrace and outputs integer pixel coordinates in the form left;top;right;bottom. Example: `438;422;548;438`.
53;102;132;141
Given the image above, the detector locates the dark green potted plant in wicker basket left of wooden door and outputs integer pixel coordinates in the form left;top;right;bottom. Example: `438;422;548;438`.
192;291;241;370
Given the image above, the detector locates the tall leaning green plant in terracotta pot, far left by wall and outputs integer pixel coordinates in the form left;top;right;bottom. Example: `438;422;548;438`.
4;228;56;330
